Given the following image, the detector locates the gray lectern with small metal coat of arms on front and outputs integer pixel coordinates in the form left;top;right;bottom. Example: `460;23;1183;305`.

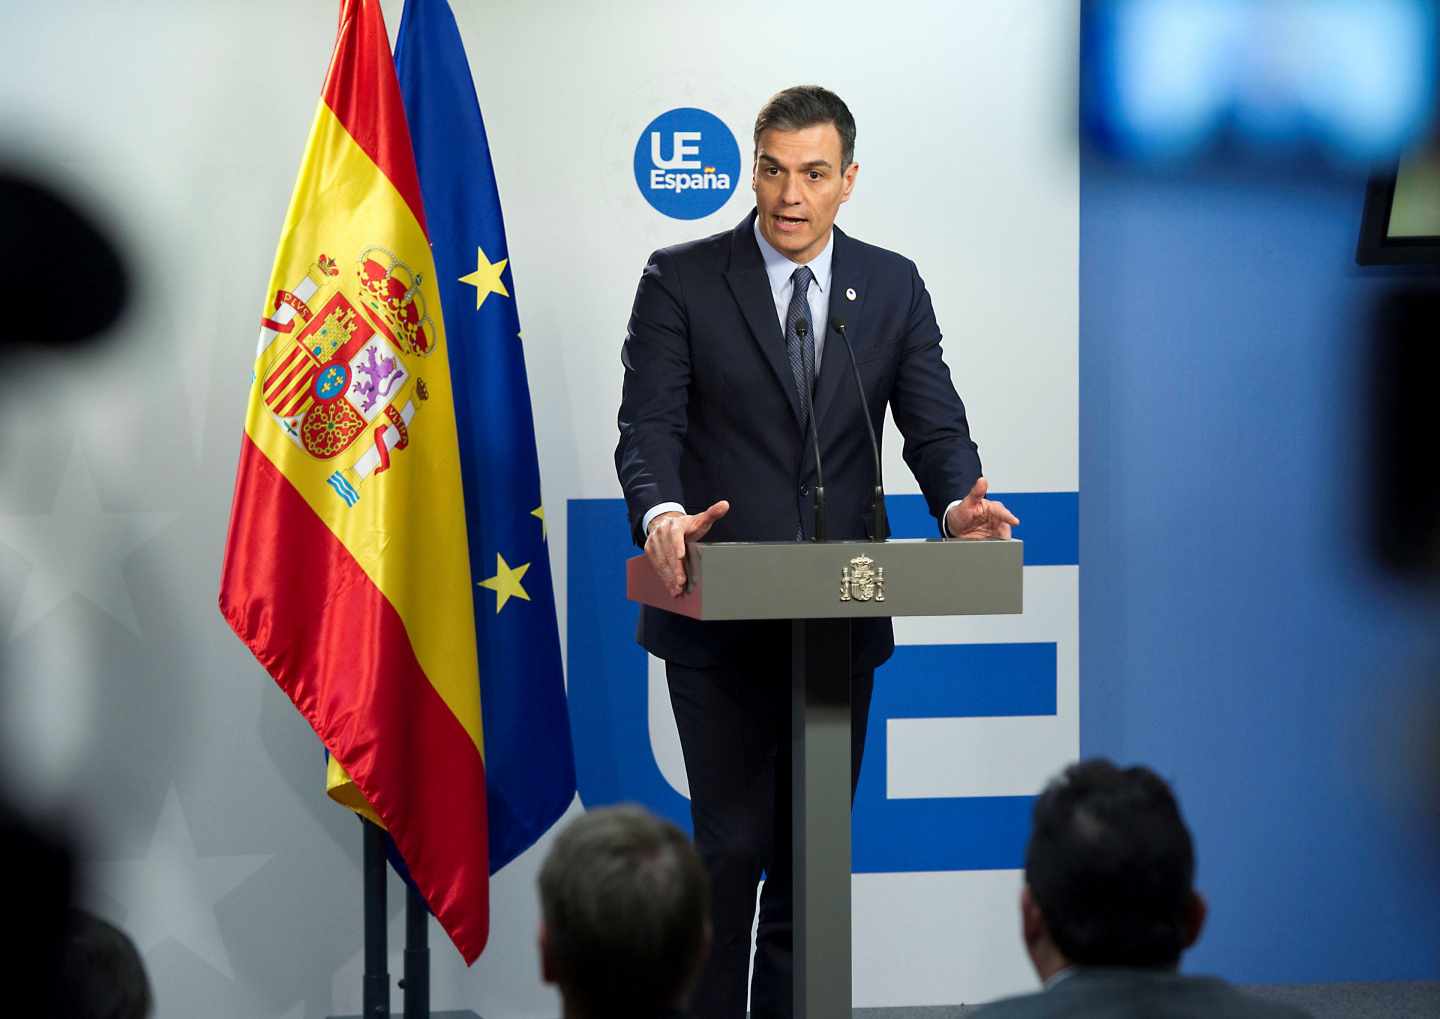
625;540;1022;1019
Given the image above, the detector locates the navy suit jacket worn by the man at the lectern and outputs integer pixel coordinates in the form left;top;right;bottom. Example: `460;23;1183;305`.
615;212;981;669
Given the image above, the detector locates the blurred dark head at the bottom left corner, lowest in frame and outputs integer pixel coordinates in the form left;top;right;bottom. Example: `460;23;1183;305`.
60;910;154;1019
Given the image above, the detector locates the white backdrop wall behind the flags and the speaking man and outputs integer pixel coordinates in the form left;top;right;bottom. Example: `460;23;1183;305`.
0;0;1079;1019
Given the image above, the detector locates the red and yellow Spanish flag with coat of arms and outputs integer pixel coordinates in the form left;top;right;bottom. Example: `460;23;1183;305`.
220;0;490;961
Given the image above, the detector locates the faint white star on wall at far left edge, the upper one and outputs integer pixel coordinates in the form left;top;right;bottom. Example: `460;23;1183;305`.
0;448;176;638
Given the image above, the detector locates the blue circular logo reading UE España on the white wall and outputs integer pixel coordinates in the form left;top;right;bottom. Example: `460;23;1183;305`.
635;107;740;219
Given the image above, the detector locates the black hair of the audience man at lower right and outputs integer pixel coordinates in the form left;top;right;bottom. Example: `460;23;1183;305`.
1025;760;1195;967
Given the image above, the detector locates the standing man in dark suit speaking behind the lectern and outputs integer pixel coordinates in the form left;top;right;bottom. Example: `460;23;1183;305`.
615;86;1018;1019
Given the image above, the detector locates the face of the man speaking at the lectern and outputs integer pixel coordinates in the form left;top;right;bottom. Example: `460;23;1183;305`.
750;122;860;265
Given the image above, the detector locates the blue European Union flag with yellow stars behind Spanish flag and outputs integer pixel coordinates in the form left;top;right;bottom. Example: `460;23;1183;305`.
395;0;575;872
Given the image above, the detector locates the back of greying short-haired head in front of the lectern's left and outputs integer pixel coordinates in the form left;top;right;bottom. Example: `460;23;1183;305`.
540;805;710;1015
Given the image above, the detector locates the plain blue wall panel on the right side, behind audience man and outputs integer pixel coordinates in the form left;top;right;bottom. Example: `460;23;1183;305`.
1080;160;1440;982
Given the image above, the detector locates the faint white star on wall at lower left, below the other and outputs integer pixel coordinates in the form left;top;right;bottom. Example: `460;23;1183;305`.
94;786;271;980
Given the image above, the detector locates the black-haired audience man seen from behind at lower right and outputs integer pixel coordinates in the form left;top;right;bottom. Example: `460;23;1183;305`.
978;760;1306;1019
